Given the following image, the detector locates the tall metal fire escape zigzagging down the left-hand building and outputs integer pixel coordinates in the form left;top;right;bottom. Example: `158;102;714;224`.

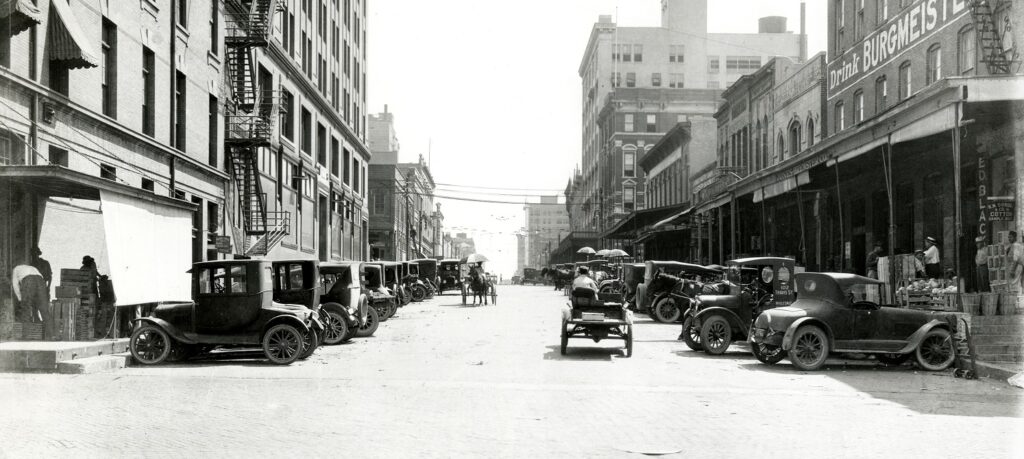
224;0;290;256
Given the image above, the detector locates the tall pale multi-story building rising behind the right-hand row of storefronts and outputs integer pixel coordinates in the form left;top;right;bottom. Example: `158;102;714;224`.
567;0;804;254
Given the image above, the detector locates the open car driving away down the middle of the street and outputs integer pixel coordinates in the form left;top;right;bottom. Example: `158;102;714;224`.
561;287;633;357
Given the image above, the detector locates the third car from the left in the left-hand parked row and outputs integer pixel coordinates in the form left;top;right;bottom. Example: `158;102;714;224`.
321;261;380;344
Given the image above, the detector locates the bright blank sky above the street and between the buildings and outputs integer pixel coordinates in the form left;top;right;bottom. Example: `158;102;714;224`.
367;0;827;279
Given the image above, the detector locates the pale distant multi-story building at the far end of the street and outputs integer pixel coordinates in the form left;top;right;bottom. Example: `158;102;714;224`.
523;196;569;267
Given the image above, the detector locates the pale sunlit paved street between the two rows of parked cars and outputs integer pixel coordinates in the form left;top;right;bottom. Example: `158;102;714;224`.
0;286;1024;458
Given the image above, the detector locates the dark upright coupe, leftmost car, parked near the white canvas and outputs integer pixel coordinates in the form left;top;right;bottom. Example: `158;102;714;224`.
129;260;324;365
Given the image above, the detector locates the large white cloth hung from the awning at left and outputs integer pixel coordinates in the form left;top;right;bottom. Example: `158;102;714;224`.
101;190;193;305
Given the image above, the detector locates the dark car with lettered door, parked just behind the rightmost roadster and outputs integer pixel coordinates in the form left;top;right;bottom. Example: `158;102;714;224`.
680;257;796;354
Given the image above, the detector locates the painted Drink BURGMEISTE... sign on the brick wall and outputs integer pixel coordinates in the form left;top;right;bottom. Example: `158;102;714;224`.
828;0;971;98
